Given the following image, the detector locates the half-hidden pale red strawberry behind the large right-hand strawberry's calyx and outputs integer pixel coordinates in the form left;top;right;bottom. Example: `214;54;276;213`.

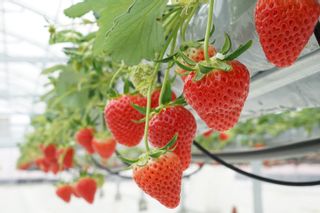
175;45;217;81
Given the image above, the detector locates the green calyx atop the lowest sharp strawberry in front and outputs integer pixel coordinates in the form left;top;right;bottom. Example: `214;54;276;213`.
118;133;178;167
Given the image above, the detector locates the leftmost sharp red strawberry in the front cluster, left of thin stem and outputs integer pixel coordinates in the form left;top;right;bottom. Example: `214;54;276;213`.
104;95;146;147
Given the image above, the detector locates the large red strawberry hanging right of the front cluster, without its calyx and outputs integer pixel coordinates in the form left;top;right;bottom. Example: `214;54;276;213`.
183;61;250;131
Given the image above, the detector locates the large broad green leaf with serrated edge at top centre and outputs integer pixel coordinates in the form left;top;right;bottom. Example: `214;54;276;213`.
104;0;167;65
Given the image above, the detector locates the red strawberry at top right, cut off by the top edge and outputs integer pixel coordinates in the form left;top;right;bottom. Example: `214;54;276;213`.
255;0;320;67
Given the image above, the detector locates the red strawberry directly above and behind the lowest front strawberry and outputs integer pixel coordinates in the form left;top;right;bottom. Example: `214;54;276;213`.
149;106;197;170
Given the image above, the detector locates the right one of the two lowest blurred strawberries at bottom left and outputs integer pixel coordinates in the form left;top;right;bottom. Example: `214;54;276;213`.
76;177;97;203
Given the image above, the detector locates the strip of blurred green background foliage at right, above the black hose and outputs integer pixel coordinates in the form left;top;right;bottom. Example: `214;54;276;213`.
197;108;320;151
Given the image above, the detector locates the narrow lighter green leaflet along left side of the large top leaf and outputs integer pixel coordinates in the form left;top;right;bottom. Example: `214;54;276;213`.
93;0;134;55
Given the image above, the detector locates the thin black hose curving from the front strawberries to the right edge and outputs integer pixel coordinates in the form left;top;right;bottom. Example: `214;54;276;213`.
193;141;320;186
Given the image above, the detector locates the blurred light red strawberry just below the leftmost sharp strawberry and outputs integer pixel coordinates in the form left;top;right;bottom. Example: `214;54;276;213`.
92;138;116;159
